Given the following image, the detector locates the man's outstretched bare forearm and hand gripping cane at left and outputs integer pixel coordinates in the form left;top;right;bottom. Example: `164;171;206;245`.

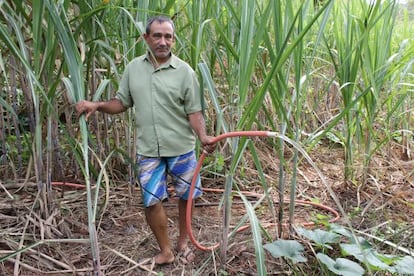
75;99;127;120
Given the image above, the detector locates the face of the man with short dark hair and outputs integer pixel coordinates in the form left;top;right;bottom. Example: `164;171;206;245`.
144;21;175;63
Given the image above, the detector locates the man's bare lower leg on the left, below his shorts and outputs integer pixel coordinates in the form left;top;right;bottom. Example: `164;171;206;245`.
145;202;174;264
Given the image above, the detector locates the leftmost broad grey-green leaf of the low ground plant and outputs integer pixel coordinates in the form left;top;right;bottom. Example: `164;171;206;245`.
263;240;307;263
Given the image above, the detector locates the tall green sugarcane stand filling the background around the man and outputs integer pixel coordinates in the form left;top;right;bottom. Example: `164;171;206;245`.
0;0;414;273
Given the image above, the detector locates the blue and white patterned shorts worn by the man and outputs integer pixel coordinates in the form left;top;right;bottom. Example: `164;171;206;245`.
137;150;202;207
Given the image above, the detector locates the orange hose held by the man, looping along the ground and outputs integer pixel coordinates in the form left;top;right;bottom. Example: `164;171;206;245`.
186;131;339;251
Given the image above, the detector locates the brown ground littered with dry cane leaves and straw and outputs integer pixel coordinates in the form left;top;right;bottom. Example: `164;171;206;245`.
0;144;414;275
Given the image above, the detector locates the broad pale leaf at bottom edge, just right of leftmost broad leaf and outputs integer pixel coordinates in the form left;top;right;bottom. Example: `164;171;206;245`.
316;253;365;276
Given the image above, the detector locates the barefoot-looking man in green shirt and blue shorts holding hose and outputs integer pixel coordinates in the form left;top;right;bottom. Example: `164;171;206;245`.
76;16;215;264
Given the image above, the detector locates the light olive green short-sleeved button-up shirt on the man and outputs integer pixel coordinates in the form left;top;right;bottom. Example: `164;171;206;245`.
115;55;202;157
